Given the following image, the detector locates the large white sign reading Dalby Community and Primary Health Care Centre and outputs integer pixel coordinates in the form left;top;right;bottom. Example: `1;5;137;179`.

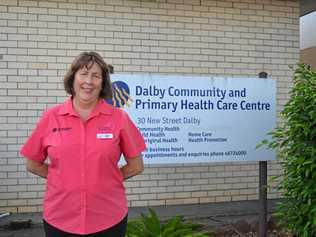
111;74;276;164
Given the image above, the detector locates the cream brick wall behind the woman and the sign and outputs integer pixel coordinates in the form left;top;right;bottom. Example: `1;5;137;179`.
0;0;299;212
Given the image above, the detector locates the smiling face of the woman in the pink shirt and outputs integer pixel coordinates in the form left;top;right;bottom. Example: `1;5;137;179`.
73;63;102;103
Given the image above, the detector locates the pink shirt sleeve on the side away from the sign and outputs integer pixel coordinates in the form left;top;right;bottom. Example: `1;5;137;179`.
20;110;48;163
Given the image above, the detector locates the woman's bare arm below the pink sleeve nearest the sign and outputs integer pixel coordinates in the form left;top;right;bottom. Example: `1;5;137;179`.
120;154;144;180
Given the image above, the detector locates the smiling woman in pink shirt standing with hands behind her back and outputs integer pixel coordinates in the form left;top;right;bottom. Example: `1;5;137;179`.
21;52;146;237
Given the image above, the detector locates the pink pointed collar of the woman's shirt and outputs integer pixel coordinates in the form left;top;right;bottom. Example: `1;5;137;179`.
58;97;114;117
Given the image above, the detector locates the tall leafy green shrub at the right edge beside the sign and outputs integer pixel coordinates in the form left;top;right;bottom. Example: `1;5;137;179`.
262;64;316;237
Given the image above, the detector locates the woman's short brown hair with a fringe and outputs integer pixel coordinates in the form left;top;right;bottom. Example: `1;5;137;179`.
64;52;112;99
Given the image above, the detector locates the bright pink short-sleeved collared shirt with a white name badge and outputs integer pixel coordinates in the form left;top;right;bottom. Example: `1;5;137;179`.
21;99;146;234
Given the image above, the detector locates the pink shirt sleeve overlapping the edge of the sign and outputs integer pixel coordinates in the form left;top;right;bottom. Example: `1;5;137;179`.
120;110;146;158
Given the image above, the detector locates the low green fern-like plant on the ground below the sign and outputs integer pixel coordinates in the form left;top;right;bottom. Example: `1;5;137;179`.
126;208;208;237
